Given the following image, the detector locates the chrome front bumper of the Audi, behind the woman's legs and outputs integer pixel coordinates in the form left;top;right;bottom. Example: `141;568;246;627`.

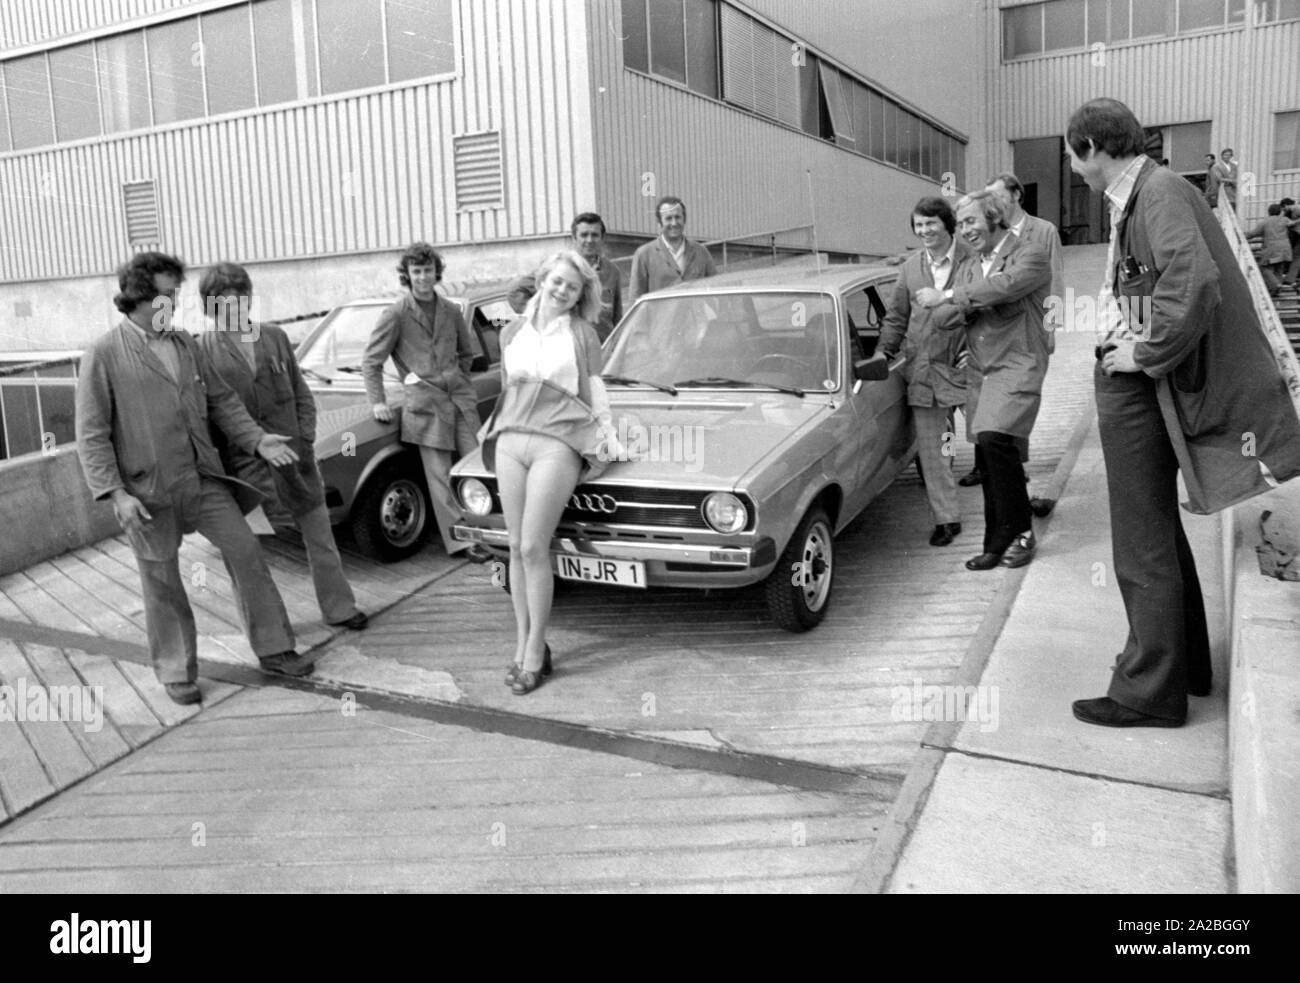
451;523;776;586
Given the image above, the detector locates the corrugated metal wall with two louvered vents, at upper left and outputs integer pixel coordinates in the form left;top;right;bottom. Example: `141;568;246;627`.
0;0;594;281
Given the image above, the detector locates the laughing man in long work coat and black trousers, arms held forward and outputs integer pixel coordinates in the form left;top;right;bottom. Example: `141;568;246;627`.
917;191;1052;571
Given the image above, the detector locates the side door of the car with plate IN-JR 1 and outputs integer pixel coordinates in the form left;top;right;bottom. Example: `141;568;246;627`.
844;278;913;515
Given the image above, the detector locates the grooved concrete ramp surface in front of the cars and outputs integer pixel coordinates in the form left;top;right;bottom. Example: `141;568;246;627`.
0;250;1196;891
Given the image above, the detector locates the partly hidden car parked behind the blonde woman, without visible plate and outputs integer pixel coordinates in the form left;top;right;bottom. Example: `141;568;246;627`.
298;282;515;562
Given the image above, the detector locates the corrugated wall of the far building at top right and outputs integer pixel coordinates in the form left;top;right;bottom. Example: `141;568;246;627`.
987;3;1300;191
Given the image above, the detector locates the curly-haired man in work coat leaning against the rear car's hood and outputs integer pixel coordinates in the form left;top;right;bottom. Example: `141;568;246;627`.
361;242;488;560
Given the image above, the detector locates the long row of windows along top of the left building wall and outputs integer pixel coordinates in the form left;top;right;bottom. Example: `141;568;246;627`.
0;0;457;151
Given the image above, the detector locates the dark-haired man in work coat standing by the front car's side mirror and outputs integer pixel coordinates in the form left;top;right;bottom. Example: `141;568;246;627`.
879;198;970;546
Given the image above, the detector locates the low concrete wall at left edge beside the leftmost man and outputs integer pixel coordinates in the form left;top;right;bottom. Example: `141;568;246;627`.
0;447;118;576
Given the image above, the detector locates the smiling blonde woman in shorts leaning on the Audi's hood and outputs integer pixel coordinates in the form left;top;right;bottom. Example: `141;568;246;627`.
484;250;625;696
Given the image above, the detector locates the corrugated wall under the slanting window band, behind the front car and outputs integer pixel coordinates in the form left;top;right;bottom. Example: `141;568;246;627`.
588;0;956;254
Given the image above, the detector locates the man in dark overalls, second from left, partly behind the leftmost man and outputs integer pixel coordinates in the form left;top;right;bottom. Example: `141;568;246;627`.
199;263;369;629
